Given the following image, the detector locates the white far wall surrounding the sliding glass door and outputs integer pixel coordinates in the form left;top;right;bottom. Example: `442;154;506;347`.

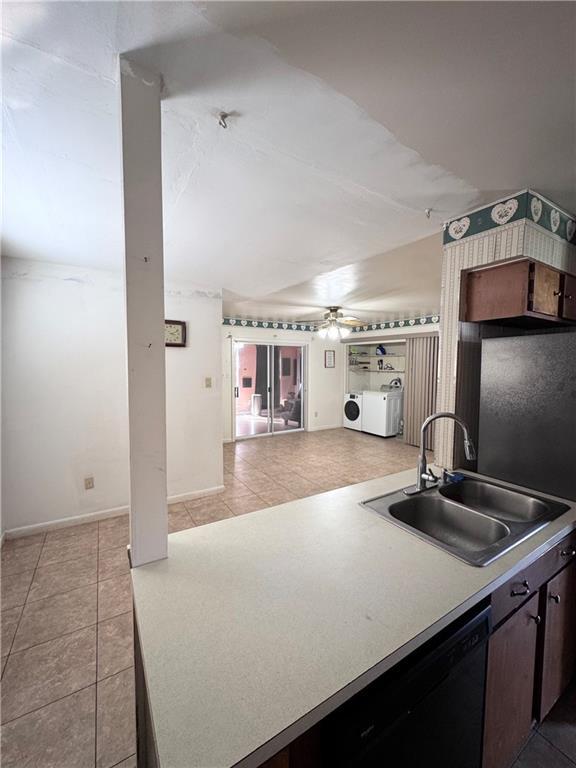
222;326;345;440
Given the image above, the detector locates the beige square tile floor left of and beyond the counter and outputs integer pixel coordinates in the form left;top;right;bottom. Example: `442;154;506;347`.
1;429;424;768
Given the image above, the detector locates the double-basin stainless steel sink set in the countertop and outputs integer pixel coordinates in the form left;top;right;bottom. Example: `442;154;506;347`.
362;475;570;566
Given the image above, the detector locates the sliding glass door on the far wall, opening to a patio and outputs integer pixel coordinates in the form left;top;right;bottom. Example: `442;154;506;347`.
233;342;304;438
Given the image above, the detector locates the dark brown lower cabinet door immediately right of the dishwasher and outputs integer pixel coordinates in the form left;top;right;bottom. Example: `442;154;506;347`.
482;594;539;768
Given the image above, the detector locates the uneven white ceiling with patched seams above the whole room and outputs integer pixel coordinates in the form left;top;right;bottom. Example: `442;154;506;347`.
3;2;576;319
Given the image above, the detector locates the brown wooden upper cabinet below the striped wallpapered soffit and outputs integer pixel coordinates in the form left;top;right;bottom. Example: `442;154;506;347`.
460;259;576;328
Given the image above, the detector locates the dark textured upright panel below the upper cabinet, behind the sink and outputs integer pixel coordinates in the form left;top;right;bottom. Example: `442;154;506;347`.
478;331;576;499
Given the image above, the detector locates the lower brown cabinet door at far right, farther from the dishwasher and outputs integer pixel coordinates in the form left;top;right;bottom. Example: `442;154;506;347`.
540;563;576;719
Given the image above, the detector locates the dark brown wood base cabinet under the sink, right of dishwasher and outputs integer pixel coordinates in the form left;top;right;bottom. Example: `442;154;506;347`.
483;532;576;768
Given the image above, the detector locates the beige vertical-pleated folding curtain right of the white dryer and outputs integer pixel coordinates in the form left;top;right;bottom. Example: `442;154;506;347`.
404;336;438;450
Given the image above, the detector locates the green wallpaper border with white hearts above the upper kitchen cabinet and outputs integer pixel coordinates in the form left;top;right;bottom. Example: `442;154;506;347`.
443;189;576;245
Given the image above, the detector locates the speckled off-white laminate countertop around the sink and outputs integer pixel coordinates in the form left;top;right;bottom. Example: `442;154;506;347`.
132;470;576;768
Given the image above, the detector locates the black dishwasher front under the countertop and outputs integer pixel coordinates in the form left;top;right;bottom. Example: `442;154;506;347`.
322;607;490;768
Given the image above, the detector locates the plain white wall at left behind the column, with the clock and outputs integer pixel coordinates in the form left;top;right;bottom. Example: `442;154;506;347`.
2;259;222;530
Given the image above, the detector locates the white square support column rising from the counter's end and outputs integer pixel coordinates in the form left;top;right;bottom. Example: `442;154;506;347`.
120;57;168;566
